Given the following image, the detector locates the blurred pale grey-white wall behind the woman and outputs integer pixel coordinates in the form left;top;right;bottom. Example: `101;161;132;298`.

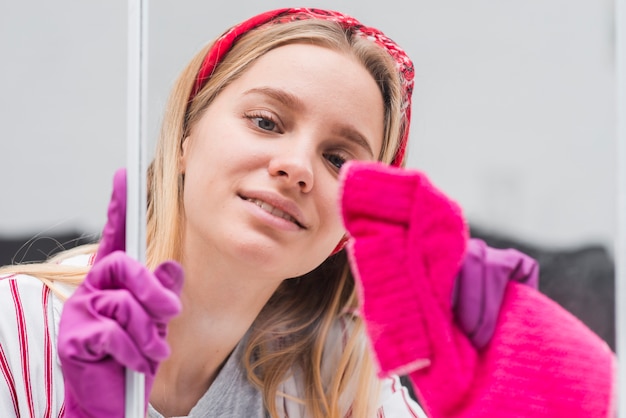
0;0;616;251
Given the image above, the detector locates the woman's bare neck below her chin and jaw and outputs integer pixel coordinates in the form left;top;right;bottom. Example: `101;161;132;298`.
150;238;280;416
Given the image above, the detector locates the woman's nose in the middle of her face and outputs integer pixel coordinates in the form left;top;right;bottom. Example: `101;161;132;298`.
268;148;314;193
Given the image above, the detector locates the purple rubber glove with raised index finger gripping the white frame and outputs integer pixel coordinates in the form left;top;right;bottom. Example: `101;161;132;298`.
58;170;183;418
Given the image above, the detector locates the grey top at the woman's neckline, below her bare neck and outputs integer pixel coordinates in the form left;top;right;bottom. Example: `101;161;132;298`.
148;338;265;418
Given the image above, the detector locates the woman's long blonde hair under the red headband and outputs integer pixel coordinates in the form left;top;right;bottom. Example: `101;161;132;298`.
1;19;404;417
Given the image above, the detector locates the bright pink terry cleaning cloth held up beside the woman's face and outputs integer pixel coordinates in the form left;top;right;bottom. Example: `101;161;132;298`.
340;162;615;418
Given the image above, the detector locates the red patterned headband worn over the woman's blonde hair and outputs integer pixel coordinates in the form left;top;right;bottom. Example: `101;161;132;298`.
190;7;414;166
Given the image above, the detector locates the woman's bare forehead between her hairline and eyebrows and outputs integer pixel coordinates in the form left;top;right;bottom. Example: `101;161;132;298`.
222;43;384;155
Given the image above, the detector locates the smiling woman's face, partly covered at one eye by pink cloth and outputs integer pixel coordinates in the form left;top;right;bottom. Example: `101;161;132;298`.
181;44;384;279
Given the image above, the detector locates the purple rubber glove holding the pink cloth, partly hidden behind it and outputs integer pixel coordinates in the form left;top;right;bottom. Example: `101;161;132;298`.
453;239;539;349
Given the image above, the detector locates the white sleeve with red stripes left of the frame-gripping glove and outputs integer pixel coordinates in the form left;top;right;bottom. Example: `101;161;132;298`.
0;275;64;418
